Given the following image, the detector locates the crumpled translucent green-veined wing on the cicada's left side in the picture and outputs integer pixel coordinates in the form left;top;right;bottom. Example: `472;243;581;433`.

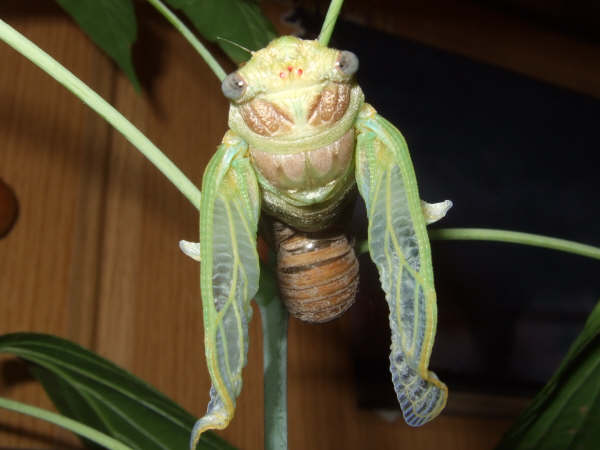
191;133;260;449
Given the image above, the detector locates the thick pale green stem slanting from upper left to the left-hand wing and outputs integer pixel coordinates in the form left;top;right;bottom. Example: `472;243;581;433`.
0;20;200;209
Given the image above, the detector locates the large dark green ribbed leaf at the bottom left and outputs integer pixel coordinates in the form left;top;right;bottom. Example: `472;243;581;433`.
0;333;233;450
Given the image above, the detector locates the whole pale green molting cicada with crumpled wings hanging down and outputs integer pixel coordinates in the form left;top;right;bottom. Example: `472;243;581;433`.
182;36;451;442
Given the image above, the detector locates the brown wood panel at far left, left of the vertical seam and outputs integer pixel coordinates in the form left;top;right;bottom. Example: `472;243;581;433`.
0;1;113;448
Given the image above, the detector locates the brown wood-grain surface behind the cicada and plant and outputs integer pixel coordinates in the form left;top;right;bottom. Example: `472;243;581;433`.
0;0;600;450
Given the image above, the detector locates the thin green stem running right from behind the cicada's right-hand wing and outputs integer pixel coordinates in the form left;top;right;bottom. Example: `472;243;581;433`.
357;228;600;259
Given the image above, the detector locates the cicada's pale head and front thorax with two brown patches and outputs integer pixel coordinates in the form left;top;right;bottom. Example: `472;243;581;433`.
222;36;363;148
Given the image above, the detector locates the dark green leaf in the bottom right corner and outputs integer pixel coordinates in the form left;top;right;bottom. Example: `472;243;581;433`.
497;303;600;450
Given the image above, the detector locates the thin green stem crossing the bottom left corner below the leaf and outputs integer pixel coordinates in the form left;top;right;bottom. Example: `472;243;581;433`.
0;397;131;450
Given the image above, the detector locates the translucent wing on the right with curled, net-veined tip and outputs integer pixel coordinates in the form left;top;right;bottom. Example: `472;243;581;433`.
356;105;448;426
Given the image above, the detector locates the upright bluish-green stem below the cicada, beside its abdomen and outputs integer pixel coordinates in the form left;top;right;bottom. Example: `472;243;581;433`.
256;264;288;450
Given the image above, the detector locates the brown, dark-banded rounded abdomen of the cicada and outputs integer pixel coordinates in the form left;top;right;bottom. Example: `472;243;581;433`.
273;222;358;323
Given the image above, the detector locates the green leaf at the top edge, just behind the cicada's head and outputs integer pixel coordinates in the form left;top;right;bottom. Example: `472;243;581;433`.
167;0;277;63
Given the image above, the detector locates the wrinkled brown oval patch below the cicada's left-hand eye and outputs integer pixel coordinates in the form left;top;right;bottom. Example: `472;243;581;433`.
240;99;294;136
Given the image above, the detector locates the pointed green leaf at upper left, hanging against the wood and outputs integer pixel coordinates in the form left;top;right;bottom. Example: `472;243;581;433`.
56;0;140;91
